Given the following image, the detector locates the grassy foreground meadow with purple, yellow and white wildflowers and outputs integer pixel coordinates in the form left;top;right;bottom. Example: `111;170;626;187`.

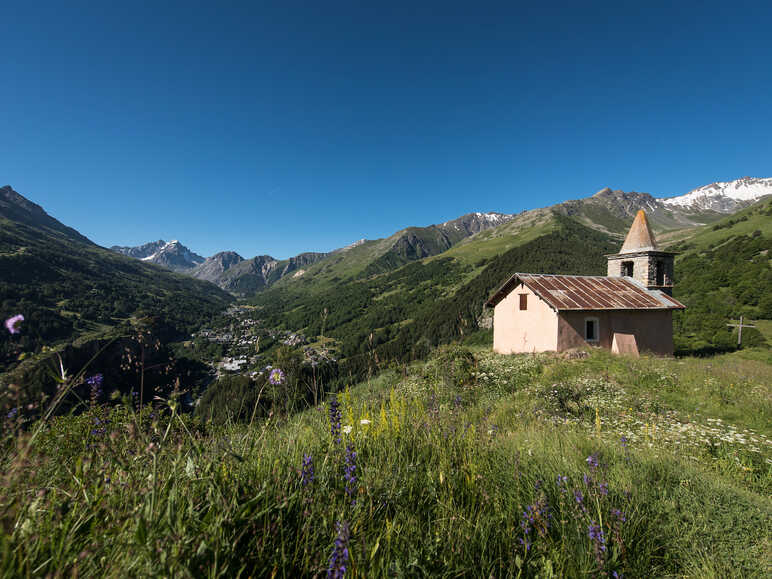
0;346;772;577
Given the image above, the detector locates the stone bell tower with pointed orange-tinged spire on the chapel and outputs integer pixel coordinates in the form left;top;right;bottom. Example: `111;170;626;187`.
606;209;676;295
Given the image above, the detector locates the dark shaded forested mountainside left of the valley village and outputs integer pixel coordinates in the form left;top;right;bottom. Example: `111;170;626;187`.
0;187;232;368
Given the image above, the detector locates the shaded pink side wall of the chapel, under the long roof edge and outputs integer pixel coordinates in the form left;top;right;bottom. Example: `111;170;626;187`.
556;310;673;356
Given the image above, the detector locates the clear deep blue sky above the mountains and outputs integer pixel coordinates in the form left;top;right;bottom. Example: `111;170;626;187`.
0;0;772;258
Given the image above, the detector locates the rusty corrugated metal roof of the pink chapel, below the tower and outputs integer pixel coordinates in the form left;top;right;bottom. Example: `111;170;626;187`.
485;273;686;311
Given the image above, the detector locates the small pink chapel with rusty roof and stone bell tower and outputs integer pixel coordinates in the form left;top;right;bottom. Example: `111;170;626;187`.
485;210;685;356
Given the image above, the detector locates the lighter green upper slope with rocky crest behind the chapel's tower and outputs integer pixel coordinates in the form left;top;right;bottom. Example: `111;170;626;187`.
260;188;724;304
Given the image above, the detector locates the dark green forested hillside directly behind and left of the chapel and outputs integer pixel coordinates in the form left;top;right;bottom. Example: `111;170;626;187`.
251;214;618;375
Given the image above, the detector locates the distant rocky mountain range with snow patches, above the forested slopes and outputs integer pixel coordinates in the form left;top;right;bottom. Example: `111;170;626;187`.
111;177;772;296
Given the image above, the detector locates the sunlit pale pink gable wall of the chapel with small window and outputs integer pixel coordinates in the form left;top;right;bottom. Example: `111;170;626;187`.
493;284;558;354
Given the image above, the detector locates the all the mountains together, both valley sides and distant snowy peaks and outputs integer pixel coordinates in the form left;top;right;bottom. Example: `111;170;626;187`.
0;178;772;386
